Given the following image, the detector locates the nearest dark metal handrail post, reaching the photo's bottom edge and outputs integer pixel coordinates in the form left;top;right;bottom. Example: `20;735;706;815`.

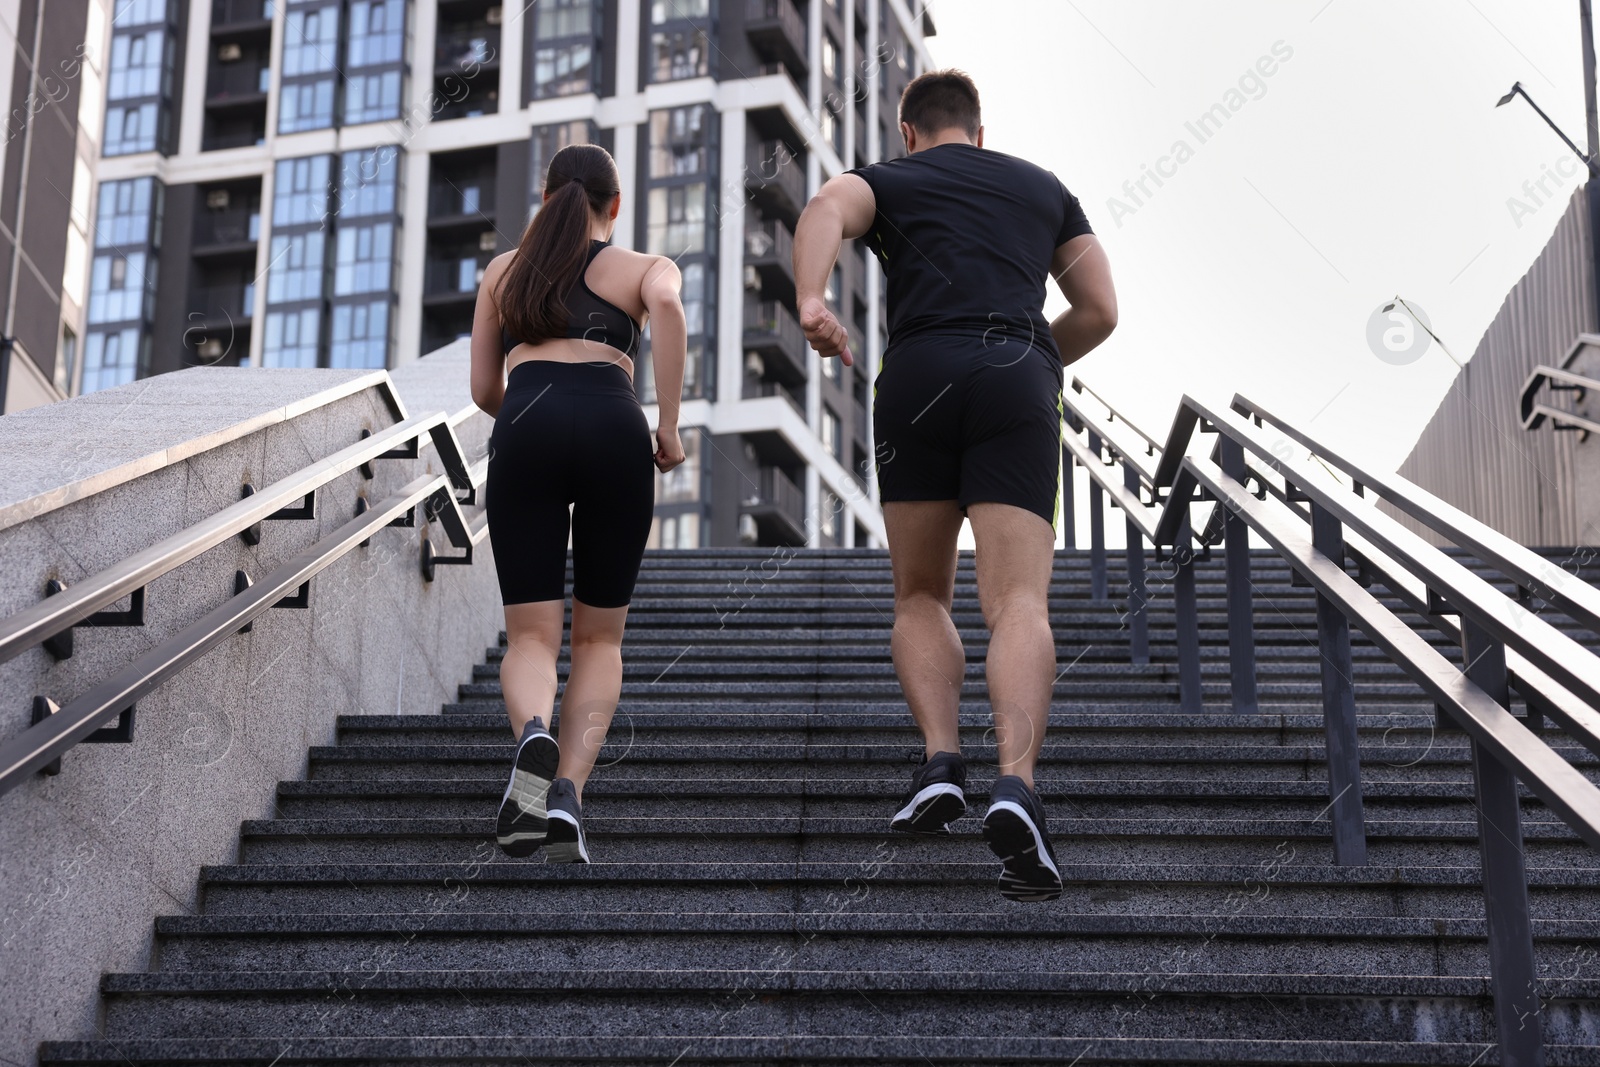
1461;614;1544;1067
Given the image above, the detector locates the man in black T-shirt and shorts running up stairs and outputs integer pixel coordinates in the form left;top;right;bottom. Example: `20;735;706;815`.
794;70;1117;901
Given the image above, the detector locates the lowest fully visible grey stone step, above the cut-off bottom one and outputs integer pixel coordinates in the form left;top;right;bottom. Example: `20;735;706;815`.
90;960;1600;1043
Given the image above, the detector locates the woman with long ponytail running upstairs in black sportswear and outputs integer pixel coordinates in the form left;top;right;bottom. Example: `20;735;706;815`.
472;144;686;864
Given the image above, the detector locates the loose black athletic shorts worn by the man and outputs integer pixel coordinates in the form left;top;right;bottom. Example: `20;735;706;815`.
872;334;1061;526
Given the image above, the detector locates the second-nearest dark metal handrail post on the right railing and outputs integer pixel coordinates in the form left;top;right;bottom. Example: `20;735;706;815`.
1310;501;1366;867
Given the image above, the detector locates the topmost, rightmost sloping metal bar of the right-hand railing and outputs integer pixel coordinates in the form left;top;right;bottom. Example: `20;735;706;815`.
1232;395;1600;632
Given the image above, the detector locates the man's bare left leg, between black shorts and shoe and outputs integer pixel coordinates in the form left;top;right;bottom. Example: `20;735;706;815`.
883;501;966;757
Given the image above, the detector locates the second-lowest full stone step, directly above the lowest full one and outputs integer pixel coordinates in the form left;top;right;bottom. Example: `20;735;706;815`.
147;910;1600;976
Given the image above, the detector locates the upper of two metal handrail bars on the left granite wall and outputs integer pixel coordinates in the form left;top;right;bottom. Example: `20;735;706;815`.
0;413;477;662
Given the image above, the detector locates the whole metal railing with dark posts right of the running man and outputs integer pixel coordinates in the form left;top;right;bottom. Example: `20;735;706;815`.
1062;383;1600;1067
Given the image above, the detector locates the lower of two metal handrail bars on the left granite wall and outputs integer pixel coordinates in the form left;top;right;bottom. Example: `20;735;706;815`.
0;475;467;795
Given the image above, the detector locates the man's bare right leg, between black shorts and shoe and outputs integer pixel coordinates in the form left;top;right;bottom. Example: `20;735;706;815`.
966;504;1056;789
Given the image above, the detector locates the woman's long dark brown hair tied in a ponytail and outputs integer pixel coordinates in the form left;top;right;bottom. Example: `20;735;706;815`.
498;144;621;344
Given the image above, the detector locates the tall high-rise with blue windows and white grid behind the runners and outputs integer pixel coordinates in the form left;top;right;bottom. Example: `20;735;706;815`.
82;0;933;547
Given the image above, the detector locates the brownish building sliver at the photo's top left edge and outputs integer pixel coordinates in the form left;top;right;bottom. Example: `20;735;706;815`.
0;0;110;411
